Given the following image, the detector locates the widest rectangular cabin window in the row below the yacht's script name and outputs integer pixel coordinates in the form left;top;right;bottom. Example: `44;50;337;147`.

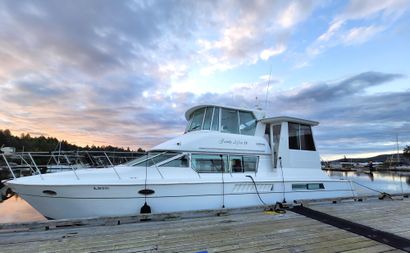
192;154;228;173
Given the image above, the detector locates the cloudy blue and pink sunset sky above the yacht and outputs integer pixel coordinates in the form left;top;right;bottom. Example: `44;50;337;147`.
0;0;410;159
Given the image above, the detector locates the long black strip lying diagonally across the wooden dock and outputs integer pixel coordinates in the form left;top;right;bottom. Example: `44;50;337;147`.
290;206;410;252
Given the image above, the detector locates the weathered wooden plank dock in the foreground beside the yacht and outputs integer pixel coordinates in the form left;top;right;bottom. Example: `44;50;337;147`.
0;198;410;252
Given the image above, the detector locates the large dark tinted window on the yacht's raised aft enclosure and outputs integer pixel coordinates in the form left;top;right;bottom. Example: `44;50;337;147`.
288;123;316;151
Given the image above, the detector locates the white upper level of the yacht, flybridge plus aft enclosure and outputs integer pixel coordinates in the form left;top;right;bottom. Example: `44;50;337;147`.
153;105;320;168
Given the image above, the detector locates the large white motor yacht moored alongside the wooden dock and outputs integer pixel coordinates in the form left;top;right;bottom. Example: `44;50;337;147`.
6;105;354;219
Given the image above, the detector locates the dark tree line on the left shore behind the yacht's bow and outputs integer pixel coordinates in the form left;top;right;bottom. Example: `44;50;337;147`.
0;129;144;152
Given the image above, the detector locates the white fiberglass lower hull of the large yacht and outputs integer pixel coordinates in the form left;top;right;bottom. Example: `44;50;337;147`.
5;180;353;219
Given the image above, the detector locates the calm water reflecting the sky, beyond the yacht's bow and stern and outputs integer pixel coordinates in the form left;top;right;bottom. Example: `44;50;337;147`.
0;171;410;223
